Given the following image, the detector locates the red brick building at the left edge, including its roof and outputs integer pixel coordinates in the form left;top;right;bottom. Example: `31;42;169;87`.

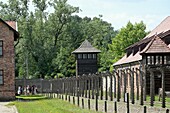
0;19;19;101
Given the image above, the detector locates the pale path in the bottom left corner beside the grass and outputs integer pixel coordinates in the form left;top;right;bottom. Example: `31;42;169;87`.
0;102;18;113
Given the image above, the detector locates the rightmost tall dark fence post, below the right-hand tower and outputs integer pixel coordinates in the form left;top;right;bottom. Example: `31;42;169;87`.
161;68;166;108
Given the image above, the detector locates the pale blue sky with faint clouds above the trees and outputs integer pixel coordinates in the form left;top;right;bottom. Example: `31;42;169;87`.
68;0;170;30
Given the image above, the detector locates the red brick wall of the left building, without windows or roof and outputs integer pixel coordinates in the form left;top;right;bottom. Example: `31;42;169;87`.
0;22;15;100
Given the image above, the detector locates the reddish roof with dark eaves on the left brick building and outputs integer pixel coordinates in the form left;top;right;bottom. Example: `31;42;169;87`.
0;18;19;41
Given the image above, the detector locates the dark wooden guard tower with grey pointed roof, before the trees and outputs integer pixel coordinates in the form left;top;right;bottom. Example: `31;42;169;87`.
72;40;101;76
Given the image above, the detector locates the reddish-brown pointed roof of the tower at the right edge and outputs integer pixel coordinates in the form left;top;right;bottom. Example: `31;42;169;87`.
140;35;170;54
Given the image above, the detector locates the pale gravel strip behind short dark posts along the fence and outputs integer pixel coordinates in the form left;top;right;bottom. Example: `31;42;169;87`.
60;96;166;113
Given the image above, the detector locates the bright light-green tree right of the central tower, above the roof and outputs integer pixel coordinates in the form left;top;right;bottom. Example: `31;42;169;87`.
109;22;147;63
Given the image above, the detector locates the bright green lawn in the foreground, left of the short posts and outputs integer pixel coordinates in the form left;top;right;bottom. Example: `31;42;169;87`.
11;99;101;113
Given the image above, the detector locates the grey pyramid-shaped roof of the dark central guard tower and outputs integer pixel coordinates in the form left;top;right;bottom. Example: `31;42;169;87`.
72;40;101;54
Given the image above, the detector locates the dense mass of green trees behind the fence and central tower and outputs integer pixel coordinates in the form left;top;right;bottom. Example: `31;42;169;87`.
0;0;146;78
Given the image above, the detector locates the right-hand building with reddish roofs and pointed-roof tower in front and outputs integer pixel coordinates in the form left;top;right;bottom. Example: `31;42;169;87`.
113;16;170;107
